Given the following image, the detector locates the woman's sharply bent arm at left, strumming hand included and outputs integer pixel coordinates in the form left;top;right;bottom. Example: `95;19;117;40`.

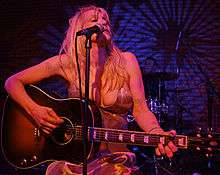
5;56;68;134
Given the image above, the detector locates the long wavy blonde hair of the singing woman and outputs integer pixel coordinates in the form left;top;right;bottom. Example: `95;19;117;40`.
60;6;128;90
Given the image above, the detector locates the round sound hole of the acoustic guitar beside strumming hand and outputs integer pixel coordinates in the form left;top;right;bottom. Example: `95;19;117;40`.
52;117;74;145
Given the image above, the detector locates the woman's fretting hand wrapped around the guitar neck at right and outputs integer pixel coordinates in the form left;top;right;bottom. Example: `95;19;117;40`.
155;130;177;158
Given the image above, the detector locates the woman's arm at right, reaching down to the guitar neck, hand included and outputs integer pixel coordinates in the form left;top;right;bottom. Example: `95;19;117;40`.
124;52;177;157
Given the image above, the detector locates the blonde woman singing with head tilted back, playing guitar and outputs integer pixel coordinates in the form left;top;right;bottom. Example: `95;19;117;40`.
5;6;177;174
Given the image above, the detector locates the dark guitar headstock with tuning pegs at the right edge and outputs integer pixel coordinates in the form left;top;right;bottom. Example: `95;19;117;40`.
188;128;220;157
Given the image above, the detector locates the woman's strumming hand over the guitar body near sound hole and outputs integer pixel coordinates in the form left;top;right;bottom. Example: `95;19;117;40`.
31;106;63;135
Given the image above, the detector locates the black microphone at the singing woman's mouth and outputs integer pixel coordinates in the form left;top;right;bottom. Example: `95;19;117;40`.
76;24;104;36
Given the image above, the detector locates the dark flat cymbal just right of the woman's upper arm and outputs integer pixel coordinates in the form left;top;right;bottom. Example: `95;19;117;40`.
142;72;178;81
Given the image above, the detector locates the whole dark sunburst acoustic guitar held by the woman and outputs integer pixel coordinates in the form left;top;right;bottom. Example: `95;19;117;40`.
1;85;219;169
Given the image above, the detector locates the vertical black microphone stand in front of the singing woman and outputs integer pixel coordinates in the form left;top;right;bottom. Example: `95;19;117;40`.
82;34;92;175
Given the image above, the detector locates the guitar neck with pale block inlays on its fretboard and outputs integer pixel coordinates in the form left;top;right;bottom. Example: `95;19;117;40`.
75;126;188;149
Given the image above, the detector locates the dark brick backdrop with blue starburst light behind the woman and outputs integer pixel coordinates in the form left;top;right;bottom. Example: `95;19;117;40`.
0;0;220;174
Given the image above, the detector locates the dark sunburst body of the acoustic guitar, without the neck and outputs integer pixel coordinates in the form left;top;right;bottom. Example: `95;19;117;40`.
1;86;101;169
